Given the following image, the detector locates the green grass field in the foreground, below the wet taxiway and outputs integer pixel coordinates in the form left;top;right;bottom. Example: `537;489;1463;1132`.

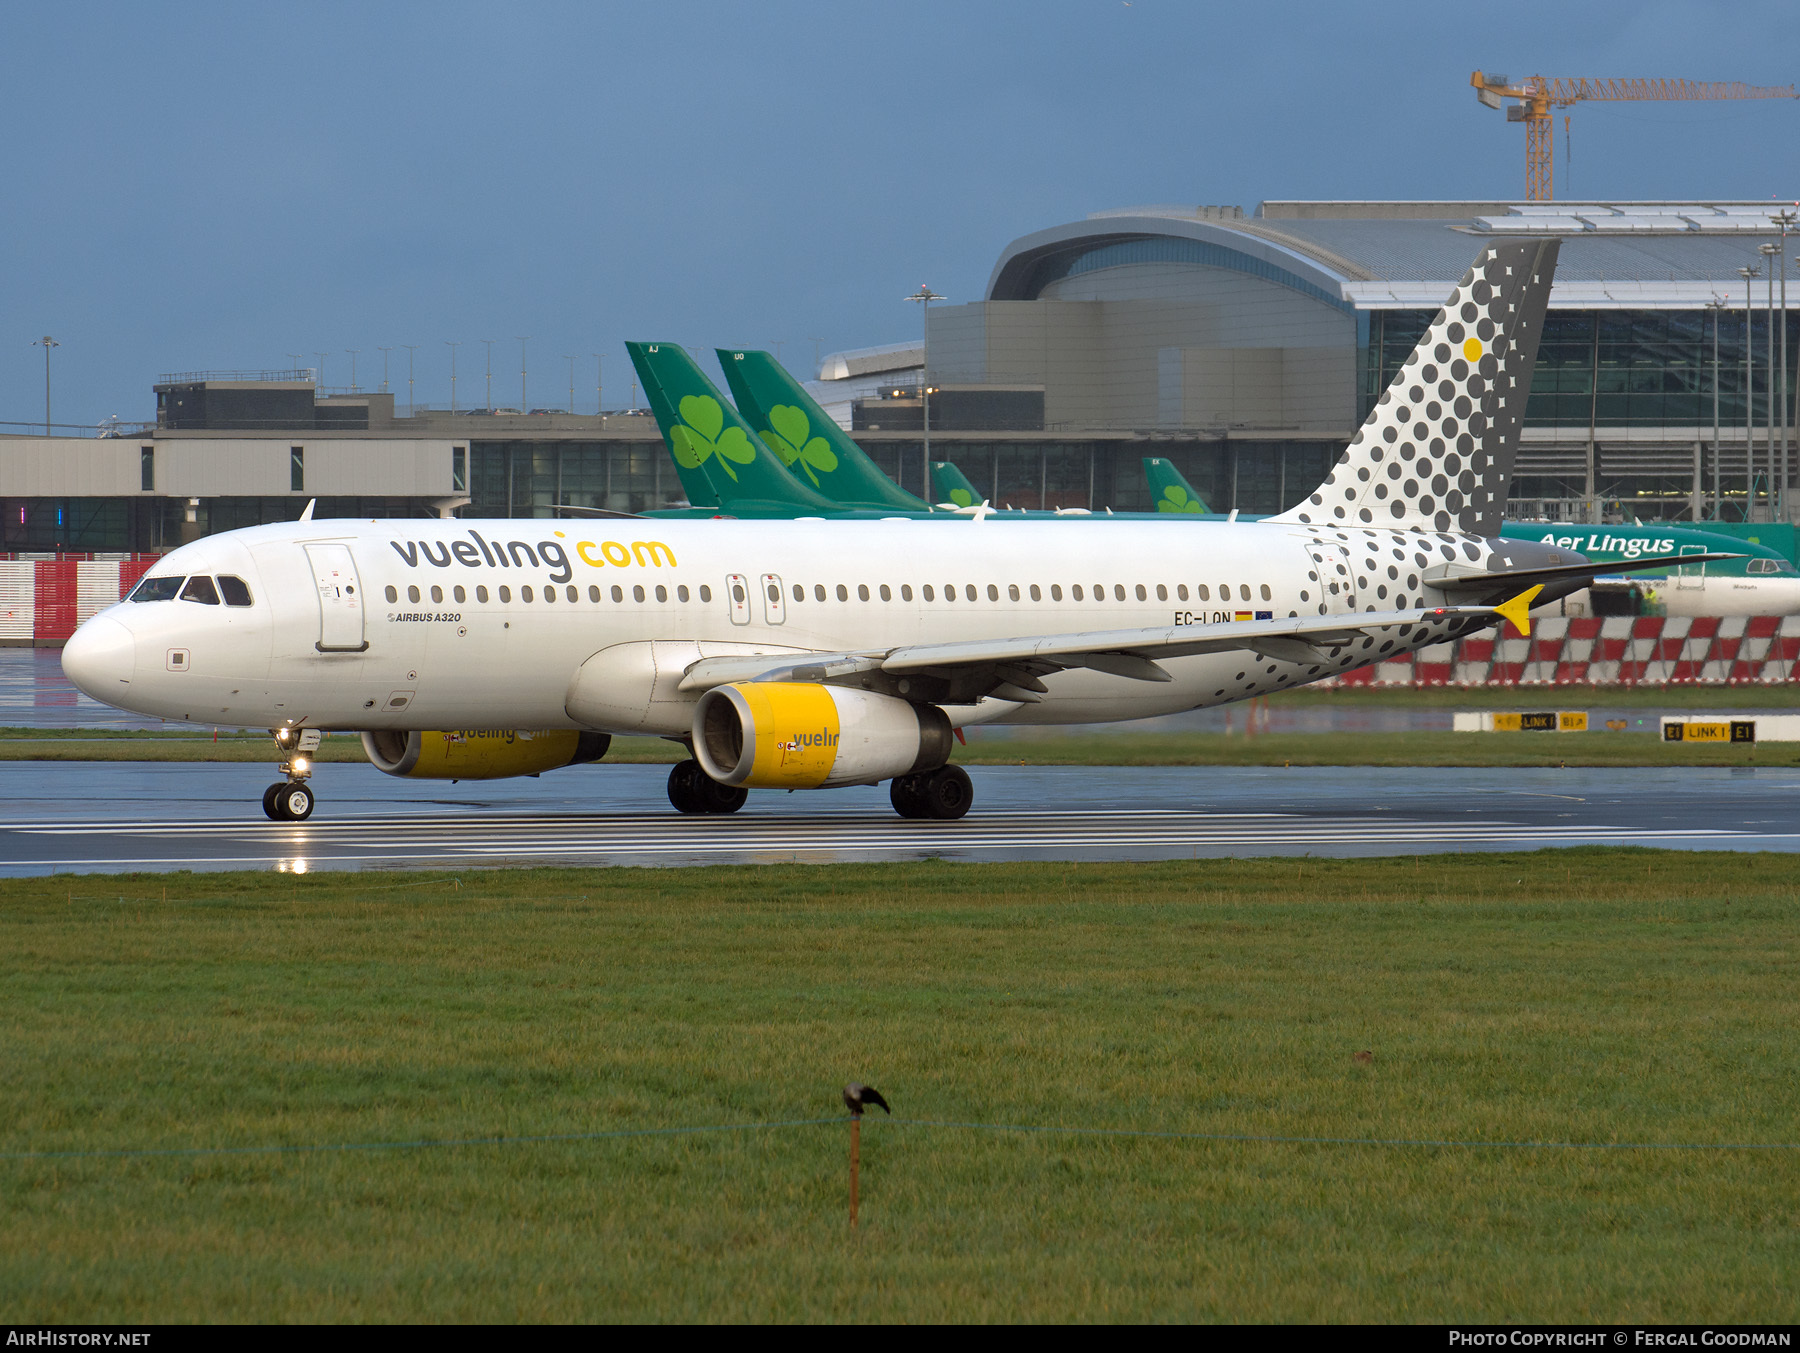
0;849;1800;1324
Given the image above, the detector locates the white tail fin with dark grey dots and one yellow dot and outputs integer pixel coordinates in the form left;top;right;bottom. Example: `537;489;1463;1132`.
1269;239;1561;536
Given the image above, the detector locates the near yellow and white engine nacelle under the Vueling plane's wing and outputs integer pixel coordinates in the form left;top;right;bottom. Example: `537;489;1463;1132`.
693;682;952;790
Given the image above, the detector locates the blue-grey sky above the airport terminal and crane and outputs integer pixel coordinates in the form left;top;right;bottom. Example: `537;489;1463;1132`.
0;0;1800;423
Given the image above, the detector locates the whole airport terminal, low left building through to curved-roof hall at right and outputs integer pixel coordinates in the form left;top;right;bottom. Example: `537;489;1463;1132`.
0;202;1800;556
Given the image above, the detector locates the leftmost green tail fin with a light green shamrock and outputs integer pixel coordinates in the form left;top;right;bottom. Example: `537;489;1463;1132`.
625;344;837;513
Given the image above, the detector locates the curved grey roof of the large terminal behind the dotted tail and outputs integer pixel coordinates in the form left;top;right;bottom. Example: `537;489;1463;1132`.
986;202;1777;311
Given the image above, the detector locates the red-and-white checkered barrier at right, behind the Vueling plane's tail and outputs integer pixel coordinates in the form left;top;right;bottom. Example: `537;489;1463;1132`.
1334;615;1800;685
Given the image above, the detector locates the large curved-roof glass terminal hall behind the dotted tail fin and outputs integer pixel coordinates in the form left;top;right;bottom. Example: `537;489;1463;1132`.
821;202;1800;520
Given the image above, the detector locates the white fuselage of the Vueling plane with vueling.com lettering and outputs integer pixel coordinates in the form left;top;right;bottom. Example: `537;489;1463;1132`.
65;518;1492;732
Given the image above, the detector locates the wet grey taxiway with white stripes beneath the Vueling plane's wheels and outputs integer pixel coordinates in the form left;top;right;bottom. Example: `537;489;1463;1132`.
0;761;1800;874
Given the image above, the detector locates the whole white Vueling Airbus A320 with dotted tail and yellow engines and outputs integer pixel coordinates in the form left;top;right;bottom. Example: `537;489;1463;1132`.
63;241;1706;820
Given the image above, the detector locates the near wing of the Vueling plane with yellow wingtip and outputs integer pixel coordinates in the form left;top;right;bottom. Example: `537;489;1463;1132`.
679;604;1504;703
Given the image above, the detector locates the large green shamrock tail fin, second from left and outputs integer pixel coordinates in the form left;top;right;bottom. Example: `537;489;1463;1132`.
716;347;931;513
